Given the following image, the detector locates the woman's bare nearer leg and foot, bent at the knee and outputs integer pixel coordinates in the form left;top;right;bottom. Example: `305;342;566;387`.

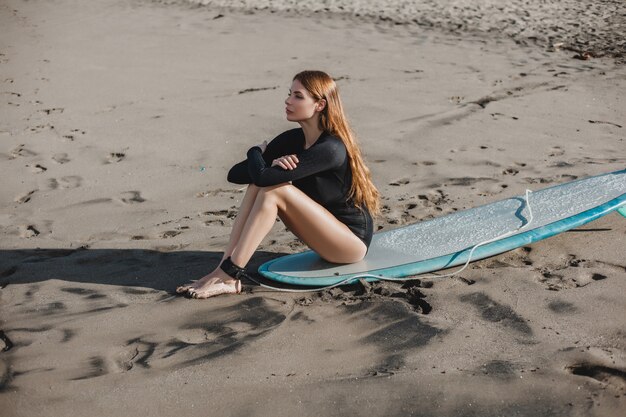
184;184;367;298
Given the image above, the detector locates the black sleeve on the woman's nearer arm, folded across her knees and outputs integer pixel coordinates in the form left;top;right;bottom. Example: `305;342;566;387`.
248;139;347;187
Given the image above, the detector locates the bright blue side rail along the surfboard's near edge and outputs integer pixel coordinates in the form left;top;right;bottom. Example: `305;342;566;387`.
258;171;626;287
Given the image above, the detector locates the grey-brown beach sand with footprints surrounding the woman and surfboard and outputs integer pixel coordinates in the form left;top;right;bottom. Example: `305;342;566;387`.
0;0;626;416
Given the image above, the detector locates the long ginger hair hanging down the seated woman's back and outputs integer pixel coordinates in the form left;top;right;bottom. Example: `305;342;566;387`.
293;71;380;215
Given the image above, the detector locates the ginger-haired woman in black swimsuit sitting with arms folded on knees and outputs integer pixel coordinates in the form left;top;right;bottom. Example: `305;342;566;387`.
176;71;380;298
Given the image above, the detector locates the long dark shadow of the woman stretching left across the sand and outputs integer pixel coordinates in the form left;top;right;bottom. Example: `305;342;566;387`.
0;248;285;294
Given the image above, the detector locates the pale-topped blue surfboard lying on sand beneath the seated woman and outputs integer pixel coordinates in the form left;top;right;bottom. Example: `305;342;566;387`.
258;169;626;287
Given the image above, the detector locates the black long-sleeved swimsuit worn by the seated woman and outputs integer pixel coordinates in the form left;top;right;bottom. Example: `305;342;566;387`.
228;128;374;249
